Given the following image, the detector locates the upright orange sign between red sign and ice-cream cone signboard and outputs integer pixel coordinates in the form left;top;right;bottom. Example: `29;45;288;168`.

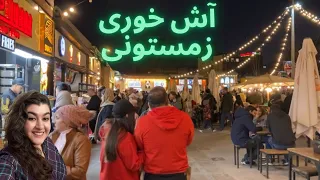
40;14;54;56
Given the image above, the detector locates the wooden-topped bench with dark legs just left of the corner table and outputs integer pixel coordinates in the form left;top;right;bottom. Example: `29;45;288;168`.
258;149;289;179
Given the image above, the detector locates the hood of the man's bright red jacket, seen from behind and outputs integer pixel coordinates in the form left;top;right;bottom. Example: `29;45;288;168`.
148;106;184;130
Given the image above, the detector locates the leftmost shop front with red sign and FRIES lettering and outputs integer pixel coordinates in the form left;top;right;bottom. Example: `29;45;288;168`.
0;0;54;95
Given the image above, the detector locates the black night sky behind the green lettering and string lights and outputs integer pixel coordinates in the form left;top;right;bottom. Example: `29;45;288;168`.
55;0;320;74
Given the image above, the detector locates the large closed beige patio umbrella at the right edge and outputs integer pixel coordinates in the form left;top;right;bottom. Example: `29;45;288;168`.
289;38;320;140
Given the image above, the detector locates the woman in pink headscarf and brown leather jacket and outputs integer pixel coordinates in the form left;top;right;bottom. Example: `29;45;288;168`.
51;105;92;180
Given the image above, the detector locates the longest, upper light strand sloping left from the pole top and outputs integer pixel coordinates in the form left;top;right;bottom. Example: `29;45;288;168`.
174;8;289;78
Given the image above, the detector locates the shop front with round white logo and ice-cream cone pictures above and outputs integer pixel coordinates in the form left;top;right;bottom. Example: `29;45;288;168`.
54;30;90;93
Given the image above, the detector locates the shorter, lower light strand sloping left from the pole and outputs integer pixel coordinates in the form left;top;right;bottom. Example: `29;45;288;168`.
217;13;285;77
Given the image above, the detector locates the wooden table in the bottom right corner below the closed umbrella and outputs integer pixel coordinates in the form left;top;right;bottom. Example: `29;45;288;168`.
288;148;320;180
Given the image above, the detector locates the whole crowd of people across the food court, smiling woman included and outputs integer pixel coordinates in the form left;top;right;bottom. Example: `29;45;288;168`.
0;79;295;180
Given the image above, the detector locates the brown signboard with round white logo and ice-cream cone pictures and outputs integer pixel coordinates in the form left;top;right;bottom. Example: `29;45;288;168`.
54;30;88;67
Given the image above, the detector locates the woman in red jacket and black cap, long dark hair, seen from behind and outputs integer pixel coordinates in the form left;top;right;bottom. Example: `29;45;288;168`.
99;100;143;180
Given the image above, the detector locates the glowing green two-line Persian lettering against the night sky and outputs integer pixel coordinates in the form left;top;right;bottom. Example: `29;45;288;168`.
99;3;216;61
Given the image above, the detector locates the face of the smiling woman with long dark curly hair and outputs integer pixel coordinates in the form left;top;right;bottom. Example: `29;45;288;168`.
24;104;51;148
